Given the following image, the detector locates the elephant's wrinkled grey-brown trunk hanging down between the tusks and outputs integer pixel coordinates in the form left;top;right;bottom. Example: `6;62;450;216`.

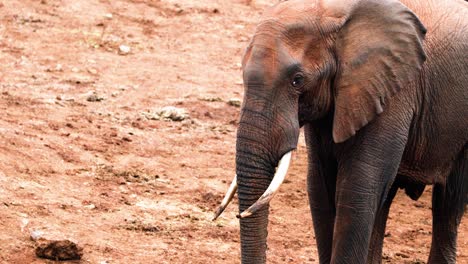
236;124;275;264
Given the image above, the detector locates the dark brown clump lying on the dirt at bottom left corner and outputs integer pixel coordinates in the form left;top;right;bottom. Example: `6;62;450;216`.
36;239;83;261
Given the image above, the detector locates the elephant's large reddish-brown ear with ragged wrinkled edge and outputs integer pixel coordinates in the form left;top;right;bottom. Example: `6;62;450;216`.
333;0;426;143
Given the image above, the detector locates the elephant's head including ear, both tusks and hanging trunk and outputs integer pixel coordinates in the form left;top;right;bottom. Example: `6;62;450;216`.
217;0;425;263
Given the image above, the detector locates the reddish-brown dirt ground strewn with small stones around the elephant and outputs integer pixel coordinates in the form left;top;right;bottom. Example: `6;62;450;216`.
0;0;468;264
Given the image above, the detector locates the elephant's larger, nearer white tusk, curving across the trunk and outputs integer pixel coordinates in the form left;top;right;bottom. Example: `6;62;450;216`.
237;151;292;218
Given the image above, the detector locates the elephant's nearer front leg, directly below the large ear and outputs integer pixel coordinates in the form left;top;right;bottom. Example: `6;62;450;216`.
331;129;406;264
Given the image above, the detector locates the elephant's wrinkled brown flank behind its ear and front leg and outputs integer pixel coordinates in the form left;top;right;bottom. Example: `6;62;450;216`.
399;1;468;184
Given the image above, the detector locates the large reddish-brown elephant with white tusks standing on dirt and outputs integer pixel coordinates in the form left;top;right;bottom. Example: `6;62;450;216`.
215;0;468;264
